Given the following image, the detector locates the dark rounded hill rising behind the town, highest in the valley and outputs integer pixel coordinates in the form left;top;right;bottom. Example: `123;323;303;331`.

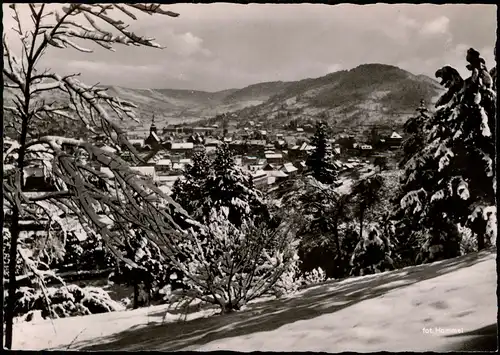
232;64;443;128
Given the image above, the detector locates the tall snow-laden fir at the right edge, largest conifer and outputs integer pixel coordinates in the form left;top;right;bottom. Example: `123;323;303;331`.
399;48;496;262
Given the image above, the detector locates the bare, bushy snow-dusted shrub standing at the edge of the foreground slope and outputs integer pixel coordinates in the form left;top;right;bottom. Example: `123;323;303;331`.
170;208;297;313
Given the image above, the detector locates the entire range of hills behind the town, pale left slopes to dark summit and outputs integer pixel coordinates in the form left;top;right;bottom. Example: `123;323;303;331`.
3;64;442;135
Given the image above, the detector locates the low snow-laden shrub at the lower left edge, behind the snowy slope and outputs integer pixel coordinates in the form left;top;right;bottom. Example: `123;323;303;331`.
7;285;125;320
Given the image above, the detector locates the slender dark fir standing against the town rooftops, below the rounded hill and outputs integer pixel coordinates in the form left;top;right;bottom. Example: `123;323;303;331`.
306;121;337;184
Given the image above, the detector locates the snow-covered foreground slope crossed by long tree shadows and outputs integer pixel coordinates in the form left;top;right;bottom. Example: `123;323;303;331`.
10;252;498;352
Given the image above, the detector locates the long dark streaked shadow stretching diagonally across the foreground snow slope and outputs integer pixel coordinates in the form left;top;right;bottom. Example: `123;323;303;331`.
71;251;496;351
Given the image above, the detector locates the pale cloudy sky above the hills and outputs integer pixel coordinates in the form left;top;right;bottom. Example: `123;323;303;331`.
3;3;497;91
